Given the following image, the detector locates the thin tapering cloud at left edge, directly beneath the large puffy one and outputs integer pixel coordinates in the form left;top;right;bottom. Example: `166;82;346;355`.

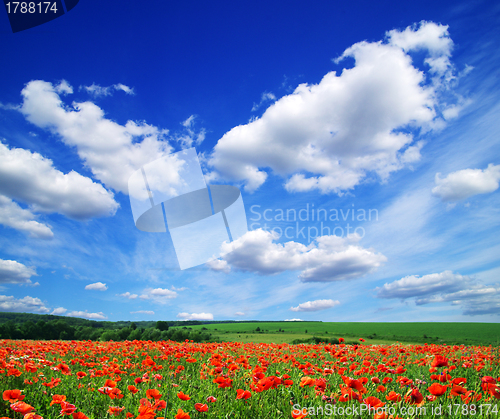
0;195;54;239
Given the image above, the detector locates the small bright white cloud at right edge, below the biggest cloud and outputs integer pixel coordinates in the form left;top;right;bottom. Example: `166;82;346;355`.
432;164;500;202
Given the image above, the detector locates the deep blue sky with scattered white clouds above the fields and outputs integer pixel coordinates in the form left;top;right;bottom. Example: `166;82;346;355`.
0;0;500;322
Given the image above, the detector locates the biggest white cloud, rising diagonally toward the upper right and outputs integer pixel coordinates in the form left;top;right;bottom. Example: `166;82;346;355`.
208;22;460;194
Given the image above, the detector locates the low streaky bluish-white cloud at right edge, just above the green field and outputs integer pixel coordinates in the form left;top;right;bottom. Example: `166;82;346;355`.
376;271;500;315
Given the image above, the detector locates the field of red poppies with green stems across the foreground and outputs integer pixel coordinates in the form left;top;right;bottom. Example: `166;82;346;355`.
0;339;500;419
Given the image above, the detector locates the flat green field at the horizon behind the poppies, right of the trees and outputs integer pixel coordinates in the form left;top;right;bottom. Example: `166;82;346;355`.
173;322;500;346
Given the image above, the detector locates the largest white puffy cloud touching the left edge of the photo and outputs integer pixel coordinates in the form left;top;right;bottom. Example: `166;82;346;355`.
0;143;119;220
